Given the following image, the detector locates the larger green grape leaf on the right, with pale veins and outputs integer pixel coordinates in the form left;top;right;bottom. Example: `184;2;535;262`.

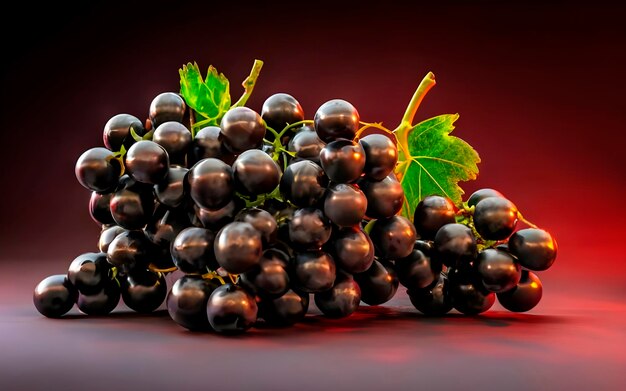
396;114;480;220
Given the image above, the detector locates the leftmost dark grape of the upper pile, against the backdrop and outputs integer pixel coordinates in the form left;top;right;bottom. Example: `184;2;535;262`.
74;147;122;193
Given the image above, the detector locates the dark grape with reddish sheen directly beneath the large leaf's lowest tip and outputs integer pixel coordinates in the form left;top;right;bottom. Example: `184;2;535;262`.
370;216;417;259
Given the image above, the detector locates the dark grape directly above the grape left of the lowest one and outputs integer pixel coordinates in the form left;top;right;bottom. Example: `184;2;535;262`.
171;227;217;274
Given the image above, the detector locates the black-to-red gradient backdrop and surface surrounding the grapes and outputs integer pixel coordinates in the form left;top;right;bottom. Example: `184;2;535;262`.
0;1;626;389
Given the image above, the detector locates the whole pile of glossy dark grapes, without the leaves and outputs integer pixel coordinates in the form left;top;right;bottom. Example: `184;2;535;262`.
34;89;556;333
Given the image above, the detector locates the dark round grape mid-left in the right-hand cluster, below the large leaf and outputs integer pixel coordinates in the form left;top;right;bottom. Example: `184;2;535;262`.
434;223;478;267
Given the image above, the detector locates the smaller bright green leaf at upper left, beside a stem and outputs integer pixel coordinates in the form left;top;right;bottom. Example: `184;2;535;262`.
179;62;231;125
